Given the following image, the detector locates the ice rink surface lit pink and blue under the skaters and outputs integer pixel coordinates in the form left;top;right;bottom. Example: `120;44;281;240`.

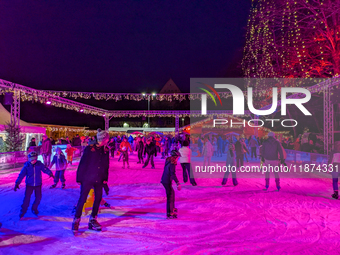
0;152;340;254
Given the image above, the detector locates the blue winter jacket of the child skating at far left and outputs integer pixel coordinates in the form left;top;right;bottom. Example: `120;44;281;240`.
15;160;53;187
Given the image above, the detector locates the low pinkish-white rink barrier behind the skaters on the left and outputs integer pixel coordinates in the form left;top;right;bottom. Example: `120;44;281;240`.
0;144;82;170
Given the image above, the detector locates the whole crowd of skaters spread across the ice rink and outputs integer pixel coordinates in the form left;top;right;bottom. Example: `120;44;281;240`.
9;129;340;234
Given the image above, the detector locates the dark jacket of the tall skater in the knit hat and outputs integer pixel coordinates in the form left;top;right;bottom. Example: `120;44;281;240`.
77;144;110;183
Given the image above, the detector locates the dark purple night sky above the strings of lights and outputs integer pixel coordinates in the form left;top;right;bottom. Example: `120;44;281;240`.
0;0;250;127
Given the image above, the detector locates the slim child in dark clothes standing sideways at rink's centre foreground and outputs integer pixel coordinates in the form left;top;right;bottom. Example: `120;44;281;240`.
161;150;182;219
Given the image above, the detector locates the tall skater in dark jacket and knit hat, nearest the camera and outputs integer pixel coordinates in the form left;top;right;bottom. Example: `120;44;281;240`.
72;129;110;231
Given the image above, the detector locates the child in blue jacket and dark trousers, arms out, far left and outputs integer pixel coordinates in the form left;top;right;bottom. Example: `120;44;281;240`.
14;151;54;219
